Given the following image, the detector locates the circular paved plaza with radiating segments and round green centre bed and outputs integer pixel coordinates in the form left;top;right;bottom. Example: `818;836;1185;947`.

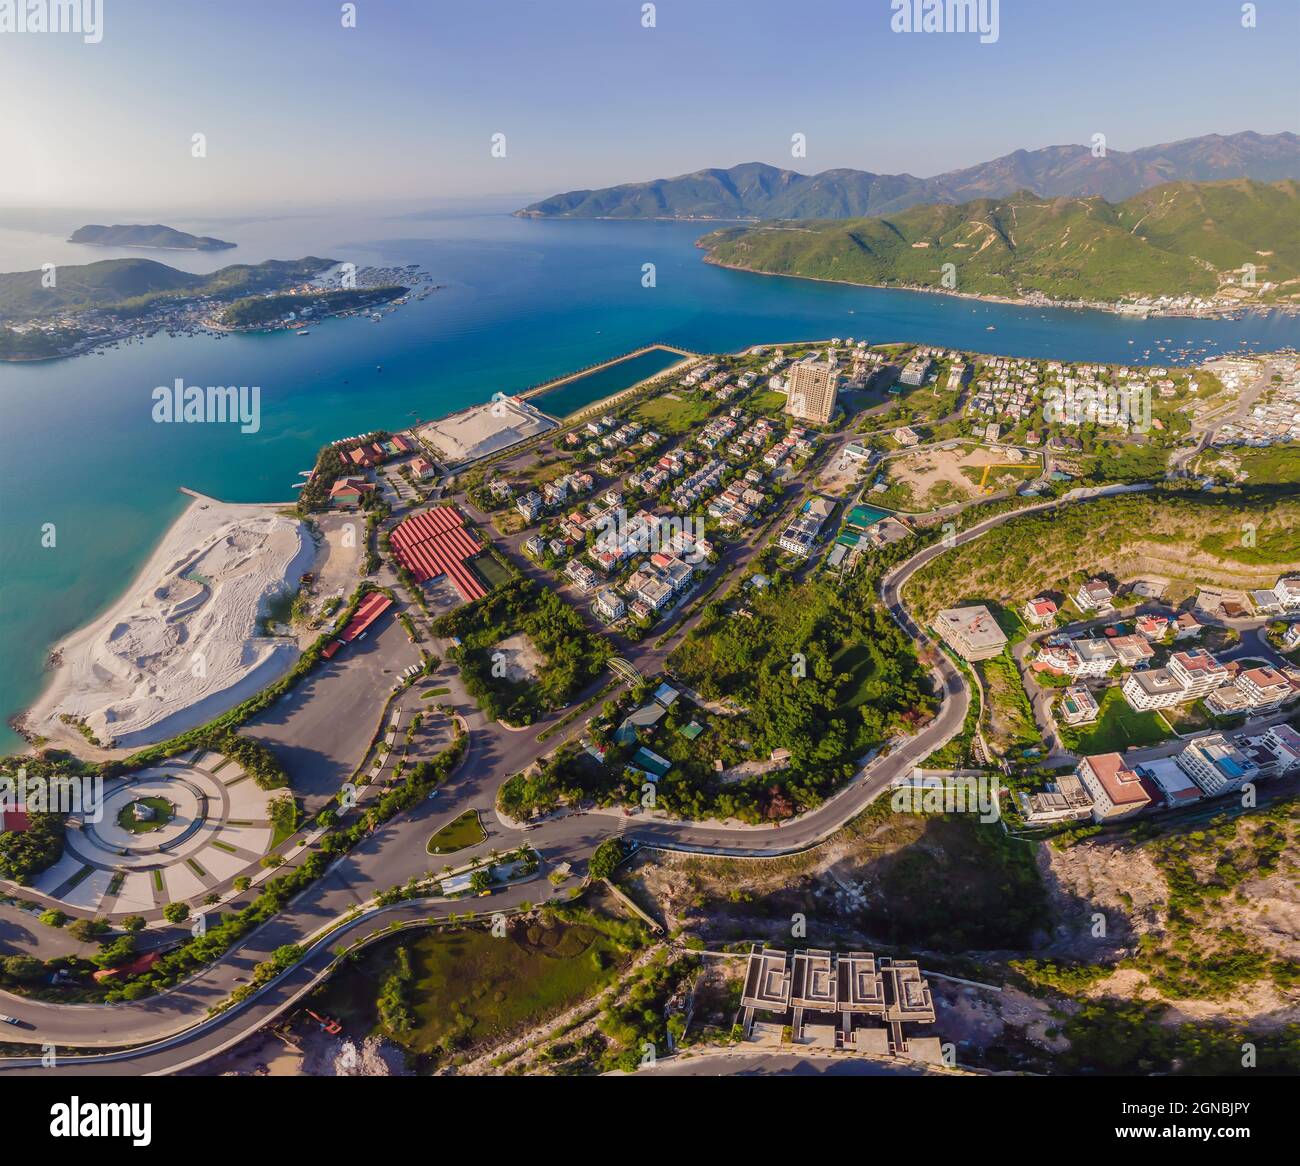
20;753;273;919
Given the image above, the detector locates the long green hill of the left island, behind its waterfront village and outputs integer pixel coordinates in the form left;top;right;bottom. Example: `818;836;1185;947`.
0;256;337;322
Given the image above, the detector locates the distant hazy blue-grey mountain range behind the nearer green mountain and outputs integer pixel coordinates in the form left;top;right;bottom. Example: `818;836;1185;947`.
515;131;1300;221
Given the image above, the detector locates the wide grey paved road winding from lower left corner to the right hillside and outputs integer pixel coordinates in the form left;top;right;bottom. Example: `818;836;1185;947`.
0;478;1206;1074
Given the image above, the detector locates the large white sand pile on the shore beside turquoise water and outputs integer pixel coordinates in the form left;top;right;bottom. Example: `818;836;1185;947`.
30;499;316;747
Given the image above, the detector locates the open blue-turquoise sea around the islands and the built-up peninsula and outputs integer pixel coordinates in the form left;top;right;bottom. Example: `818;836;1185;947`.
0;204;1300;751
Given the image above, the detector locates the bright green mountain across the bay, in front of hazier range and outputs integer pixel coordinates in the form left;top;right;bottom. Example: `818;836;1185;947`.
698;178;1300;302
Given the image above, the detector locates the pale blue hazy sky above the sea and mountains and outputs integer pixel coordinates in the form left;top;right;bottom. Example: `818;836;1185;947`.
0;0;1300;209
